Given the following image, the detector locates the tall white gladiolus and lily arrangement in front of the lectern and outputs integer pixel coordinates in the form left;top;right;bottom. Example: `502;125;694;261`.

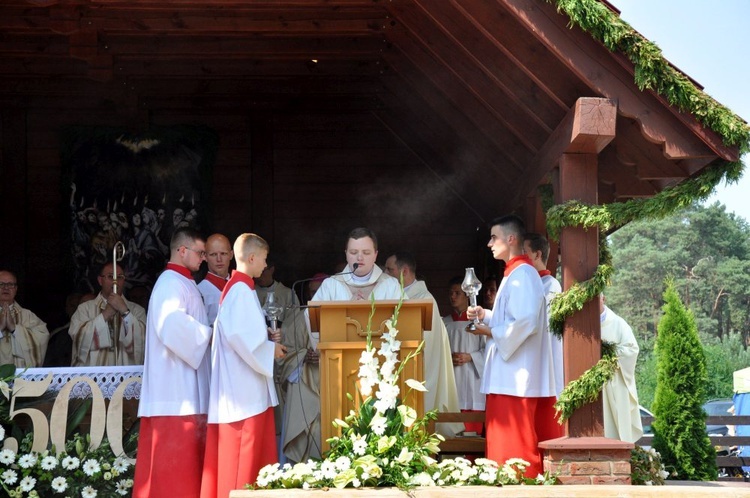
253;302;556;489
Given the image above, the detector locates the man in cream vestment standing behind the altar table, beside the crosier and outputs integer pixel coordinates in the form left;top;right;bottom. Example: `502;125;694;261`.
68;263;146;367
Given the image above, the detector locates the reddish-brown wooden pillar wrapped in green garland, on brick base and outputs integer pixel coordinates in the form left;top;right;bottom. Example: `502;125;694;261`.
560;154;604;437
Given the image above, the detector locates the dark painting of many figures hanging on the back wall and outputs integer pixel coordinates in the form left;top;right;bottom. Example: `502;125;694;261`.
63;127;217;293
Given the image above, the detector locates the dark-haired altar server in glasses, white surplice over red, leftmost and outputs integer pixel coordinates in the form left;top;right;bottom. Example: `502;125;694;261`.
133;228;211;498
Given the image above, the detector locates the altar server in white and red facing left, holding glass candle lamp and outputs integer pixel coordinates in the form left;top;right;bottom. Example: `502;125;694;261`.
467;216;560;477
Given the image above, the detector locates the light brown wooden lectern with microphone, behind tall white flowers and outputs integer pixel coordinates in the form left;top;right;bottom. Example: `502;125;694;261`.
308;299;433;451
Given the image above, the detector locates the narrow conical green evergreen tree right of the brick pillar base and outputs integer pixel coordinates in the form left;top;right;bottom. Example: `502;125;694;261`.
653;280;717;481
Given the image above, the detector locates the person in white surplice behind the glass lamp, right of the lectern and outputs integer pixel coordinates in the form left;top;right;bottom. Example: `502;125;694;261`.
443;276;487;435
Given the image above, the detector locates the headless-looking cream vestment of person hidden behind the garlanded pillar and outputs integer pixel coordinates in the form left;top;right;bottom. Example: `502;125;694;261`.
599;294;643;443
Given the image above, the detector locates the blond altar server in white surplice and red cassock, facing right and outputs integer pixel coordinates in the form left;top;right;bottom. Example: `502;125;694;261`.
201;233;285;498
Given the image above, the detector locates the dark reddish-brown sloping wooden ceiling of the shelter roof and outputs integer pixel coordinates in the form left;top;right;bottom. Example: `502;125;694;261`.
0;0;737;220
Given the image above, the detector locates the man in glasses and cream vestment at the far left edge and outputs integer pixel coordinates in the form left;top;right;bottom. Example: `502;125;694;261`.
0;270;49;368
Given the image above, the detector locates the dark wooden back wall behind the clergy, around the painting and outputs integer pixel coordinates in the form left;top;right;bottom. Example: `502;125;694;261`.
0;107;500;327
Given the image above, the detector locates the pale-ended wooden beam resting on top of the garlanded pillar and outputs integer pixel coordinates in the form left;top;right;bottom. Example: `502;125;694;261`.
515;97;617;208
